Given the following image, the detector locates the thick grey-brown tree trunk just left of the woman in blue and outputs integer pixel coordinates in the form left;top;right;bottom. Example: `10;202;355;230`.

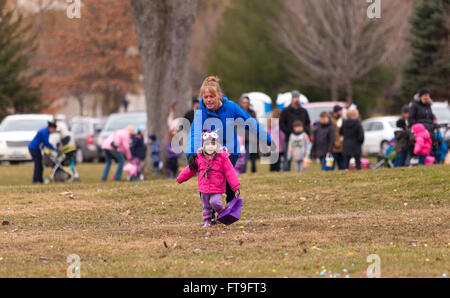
131;0;197;171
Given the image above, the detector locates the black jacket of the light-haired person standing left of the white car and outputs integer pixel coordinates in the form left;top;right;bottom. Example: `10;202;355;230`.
341;119;364;156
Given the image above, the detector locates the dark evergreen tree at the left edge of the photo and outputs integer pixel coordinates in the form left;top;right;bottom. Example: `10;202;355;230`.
0;0;43;119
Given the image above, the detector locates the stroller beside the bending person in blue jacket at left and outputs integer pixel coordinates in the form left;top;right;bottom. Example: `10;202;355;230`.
43;145;81;184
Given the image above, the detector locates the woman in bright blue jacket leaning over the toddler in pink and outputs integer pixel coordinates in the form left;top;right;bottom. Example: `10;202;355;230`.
187;77;273;208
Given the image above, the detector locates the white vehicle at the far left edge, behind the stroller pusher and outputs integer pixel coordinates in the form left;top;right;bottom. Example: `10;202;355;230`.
0;114;54;163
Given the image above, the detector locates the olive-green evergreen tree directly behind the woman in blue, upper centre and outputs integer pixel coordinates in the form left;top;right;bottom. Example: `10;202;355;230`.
207;0;288;99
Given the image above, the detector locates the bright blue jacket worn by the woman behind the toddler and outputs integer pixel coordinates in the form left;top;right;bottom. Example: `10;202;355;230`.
186;95;272;156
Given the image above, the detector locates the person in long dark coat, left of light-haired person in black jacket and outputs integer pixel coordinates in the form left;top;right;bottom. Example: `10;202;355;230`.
312;112;335;171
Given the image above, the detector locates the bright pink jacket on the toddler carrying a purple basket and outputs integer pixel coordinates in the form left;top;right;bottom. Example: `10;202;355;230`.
177;152;240;194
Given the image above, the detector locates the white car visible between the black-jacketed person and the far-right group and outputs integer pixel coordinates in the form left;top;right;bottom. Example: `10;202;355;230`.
362;116;400;155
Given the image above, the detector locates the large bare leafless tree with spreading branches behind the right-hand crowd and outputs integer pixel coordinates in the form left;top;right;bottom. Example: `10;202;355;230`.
274;0;405;102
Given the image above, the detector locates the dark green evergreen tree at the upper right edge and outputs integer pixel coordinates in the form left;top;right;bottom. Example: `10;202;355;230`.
403;0;450;102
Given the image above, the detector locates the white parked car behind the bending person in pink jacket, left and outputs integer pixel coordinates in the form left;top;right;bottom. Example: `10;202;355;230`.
96;112;147;160
